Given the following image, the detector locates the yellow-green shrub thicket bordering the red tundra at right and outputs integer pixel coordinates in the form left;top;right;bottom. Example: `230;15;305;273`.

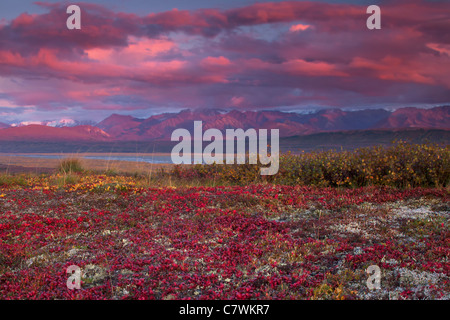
172;141;450;188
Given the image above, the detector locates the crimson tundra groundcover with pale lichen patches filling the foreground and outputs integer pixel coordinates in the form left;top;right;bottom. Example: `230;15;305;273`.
0;182;450;299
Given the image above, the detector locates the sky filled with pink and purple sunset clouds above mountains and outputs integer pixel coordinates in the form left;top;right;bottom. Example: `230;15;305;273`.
0;0;450;123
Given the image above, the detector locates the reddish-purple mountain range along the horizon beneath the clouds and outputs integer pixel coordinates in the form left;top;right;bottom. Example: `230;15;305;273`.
0;106;450;141
